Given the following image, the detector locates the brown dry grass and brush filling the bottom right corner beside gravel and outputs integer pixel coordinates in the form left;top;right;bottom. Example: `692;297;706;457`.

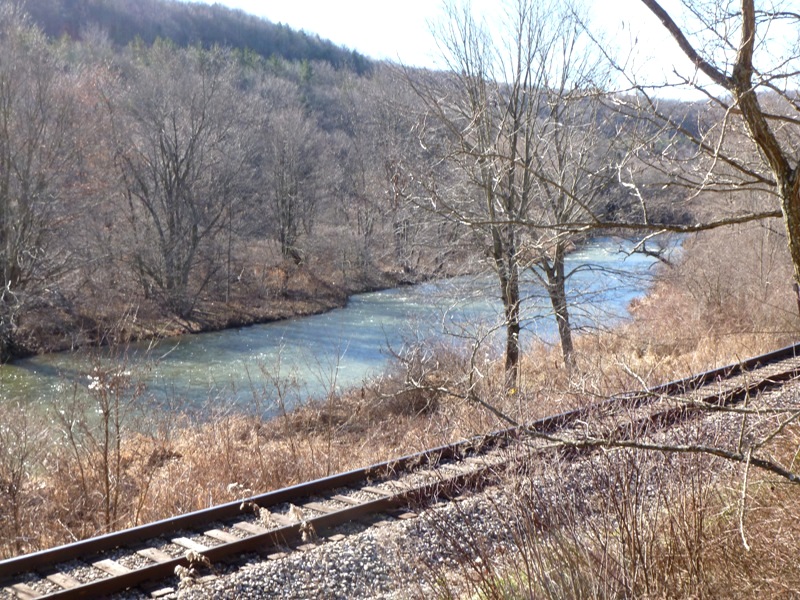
415;424;800;600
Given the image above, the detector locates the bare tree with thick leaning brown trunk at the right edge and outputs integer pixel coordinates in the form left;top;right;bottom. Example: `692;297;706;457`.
614;0;800;283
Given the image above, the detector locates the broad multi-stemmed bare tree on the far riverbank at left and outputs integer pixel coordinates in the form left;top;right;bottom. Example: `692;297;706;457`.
112;44;252;317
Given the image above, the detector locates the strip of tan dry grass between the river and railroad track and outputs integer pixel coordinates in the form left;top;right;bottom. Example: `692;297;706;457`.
0;223;797;568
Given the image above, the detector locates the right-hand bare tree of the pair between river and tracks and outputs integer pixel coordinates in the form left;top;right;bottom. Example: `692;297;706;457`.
521;31;617;370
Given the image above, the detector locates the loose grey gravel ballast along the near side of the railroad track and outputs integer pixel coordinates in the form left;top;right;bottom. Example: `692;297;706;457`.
120;384;800;600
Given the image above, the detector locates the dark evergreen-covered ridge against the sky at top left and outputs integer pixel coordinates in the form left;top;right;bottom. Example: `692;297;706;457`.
25;0;371;74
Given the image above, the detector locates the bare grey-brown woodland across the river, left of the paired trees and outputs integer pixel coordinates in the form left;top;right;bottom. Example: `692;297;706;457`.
0;2;442;359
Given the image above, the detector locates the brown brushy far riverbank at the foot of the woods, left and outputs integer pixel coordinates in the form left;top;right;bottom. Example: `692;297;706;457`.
13;266;424;359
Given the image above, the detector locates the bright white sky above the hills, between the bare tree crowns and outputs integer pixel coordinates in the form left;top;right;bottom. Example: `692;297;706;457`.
180;0;681;79
